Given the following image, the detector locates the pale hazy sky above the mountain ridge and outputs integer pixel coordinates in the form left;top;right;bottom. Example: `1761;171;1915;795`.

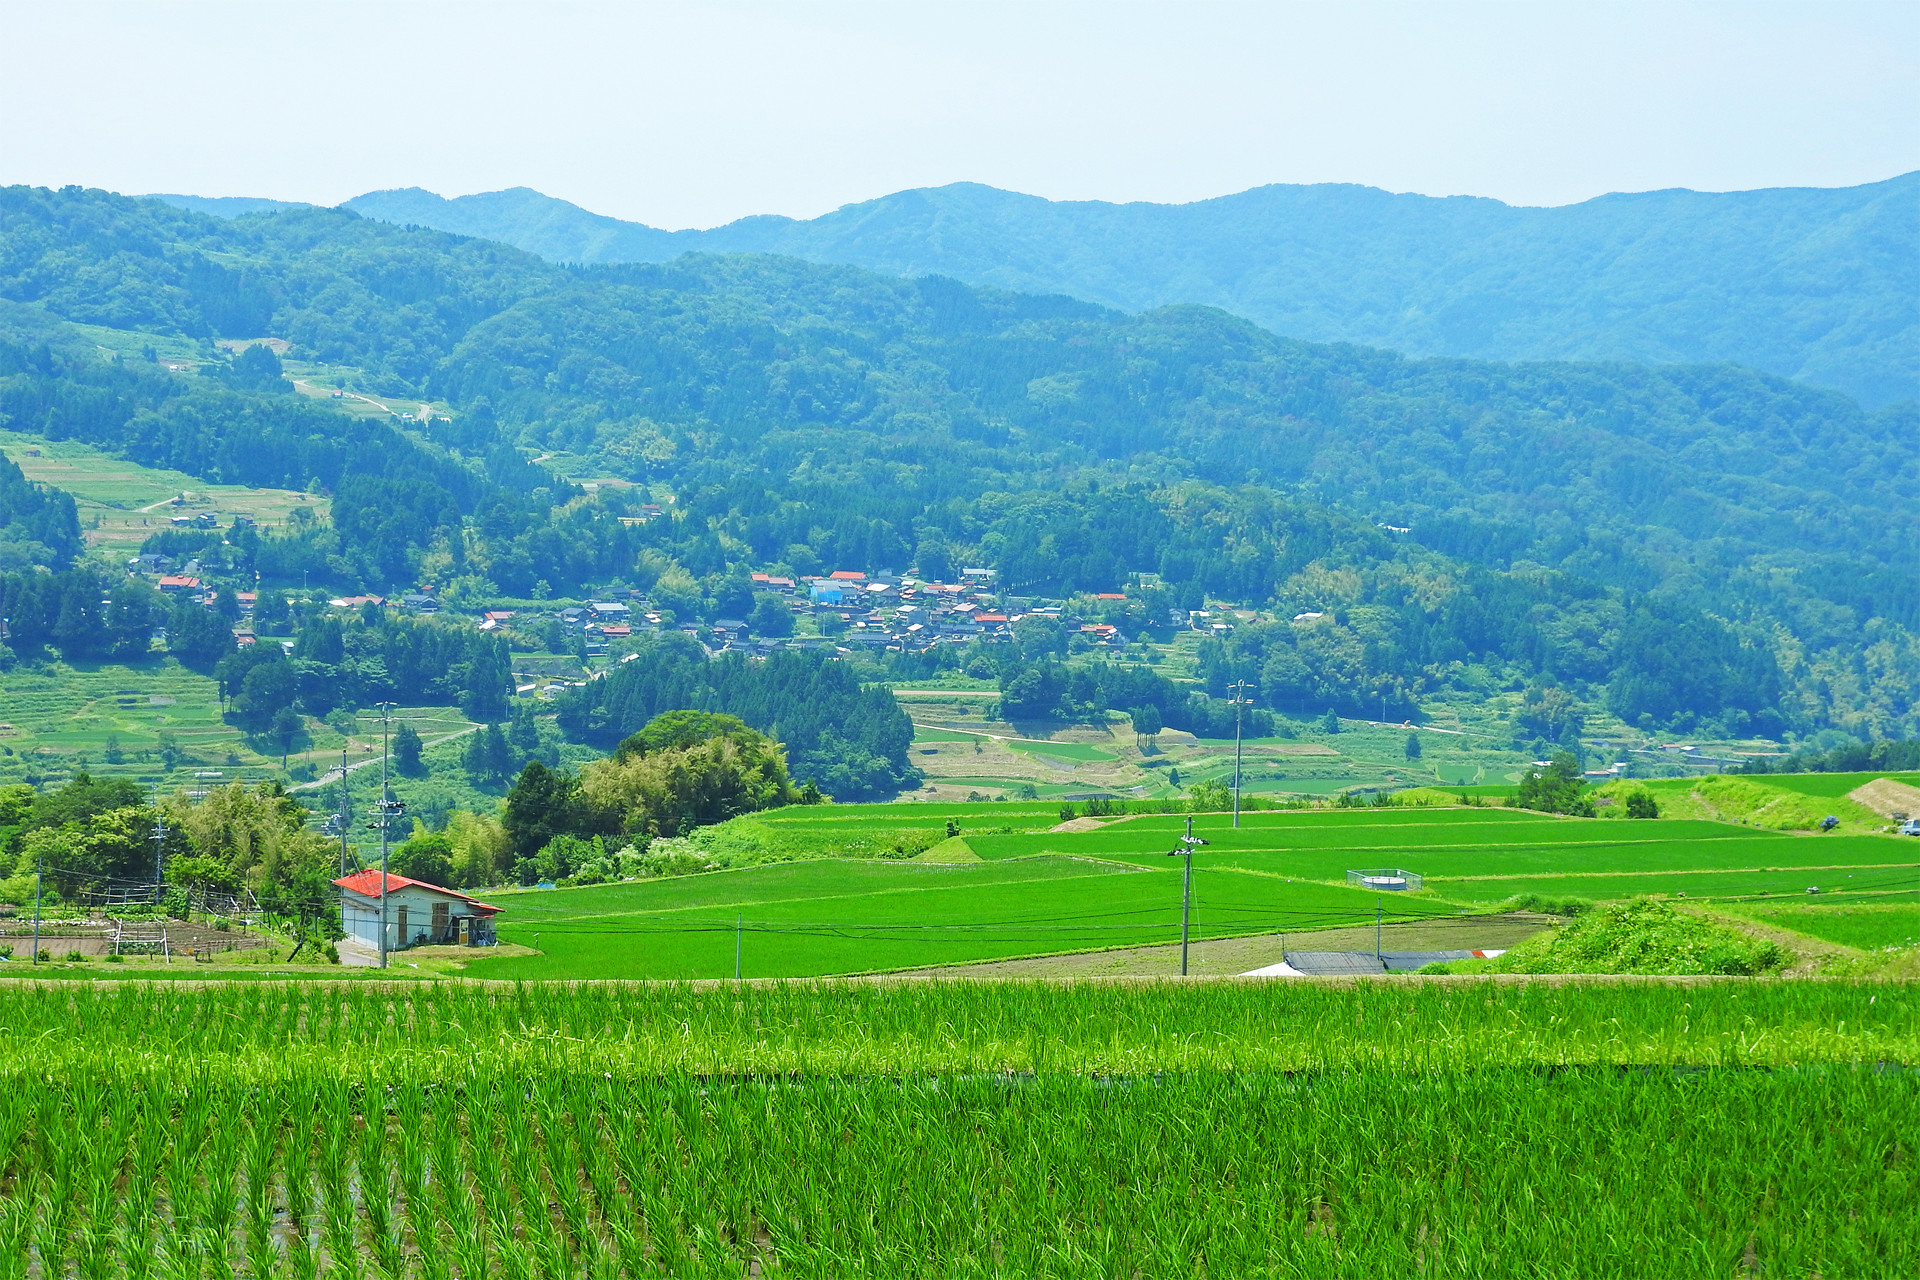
0;0;1920;228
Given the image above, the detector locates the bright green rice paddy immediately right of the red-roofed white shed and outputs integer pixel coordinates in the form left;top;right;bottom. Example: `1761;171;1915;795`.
470;858;1428;979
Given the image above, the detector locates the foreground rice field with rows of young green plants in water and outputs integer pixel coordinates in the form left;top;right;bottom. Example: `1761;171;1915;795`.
0;983;1920;1278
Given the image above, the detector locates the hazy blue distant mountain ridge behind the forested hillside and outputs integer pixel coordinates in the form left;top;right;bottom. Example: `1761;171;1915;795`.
157;173;1920;407
